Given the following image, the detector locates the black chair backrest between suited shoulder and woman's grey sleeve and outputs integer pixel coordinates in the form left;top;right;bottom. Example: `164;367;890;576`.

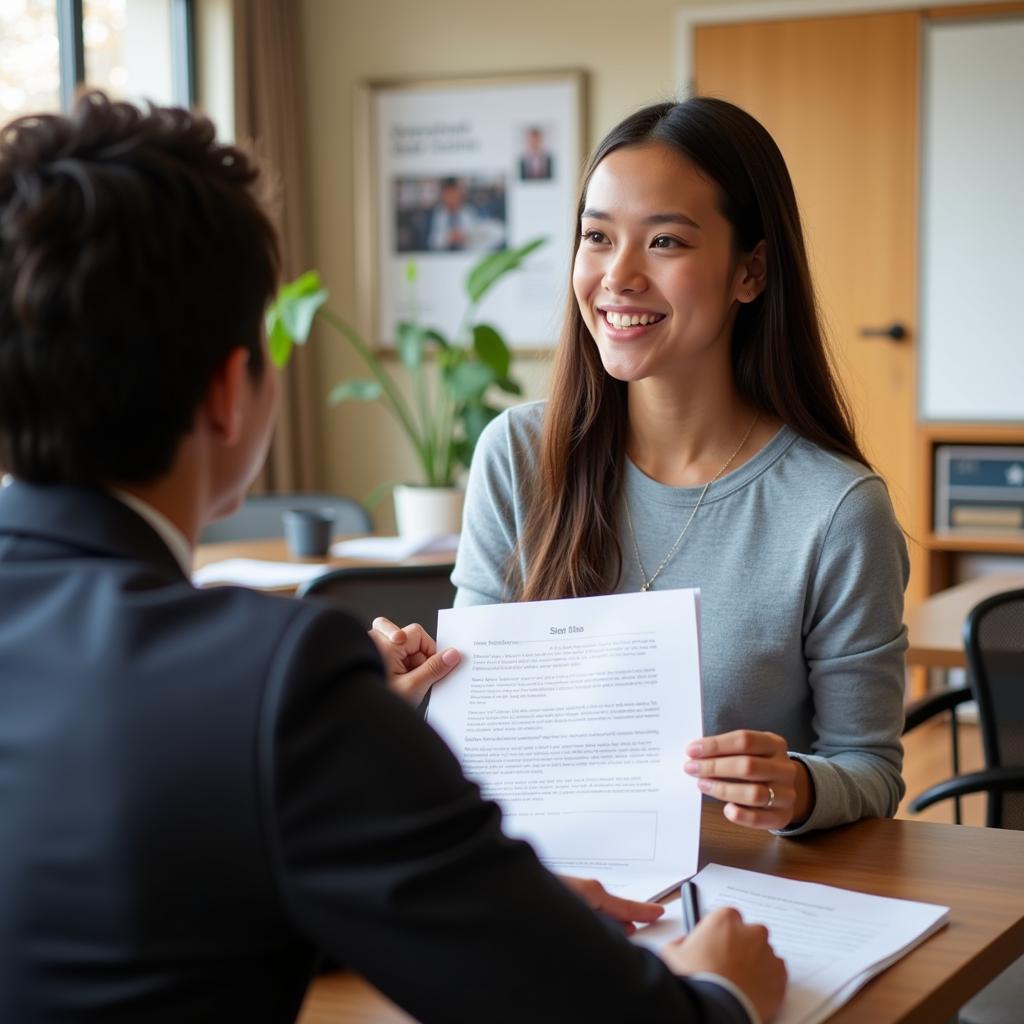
298;562;455;637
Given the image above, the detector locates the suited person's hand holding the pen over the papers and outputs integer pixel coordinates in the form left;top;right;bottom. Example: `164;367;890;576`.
662;907;785;1021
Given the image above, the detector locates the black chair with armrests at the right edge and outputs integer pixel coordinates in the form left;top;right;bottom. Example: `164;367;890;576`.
906;590;1024;1024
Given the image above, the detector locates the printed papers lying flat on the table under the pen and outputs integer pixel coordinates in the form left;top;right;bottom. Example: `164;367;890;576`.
633;864;949;1024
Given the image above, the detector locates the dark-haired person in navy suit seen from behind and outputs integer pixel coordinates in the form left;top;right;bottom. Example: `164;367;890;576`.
0;94;784;1024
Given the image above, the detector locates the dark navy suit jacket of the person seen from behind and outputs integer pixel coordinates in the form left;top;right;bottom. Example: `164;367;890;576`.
0;483;745;1024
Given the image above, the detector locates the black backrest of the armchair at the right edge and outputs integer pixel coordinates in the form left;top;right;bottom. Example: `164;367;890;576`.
964;590;1024;829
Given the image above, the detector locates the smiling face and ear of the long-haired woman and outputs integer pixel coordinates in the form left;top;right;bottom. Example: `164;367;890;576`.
572;142;765;395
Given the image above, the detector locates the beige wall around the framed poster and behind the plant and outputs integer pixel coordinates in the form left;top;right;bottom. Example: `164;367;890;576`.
301;0;679;526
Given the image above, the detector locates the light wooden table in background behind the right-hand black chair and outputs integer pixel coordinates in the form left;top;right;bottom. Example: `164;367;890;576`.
905;573;1024;669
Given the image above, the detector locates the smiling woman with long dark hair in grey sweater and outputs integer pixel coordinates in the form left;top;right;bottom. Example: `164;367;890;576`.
453;98;907;834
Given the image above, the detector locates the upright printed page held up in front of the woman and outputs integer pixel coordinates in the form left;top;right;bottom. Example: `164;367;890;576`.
428;590;701;899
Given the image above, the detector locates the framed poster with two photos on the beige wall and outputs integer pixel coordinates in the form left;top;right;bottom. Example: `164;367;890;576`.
355;71;585;350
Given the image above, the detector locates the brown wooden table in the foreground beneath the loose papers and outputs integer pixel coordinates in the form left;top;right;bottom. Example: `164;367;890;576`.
299;803;1024;1024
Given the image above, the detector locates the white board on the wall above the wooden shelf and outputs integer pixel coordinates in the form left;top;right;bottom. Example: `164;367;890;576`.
919;17;1024;421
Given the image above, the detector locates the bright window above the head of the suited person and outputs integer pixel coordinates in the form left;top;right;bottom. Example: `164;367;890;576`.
0;0;196;123
